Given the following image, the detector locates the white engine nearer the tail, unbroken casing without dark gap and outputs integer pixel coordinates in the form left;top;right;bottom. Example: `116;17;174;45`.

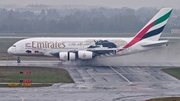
78;51;93;59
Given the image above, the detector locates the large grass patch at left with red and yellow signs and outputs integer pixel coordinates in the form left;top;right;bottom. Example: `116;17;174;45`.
0;66;73;83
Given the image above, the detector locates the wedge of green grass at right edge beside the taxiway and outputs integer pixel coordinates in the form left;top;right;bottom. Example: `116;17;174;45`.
162;68;180;80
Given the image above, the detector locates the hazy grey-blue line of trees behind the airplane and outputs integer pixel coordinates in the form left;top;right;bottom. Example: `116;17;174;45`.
0;8;180;33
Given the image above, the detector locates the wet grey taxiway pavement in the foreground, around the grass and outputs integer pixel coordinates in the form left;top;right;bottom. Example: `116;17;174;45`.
0;61;180;101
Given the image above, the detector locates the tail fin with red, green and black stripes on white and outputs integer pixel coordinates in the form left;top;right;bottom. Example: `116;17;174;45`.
118;8;173;51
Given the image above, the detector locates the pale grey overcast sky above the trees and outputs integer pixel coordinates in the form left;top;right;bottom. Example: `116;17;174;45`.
0;0;180;9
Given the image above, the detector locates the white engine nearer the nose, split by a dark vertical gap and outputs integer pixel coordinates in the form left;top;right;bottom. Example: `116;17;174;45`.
59;52;76;61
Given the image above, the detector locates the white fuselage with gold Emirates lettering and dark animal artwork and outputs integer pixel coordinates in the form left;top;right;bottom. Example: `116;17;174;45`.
8;37;162;57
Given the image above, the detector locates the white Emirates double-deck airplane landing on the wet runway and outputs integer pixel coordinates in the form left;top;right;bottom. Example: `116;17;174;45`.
7;8;173;61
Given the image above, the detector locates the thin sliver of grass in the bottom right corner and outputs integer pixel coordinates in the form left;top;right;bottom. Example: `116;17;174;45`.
147;97;180;101
